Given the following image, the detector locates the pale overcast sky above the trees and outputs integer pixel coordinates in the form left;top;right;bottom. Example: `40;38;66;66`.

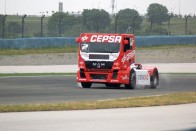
0;0;196;16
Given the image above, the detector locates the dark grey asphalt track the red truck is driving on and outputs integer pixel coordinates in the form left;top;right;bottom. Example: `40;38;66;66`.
0;74;196;105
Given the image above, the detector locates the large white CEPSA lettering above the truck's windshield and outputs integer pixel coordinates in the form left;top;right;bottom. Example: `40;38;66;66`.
90;35;122;43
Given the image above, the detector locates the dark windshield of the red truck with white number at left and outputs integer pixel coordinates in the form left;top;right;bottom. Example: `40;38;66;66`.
80;42;120;53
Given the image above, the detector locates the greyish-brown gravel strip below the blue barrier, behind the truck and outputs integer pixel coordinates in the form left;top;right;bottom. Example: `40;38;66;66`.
0;46;196;66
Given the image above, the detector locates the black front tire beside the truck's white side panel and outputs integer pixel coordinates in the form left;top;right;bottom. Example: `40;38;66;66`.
125;70;136;89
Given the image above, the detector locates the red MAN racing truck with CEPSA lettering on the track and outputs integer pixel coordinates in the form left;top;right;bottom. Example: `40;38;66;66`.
76;33;159;89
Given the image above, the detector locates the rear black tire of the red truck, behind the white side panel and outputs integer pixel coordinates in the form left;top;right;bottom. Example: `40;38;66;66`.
150;70;159;89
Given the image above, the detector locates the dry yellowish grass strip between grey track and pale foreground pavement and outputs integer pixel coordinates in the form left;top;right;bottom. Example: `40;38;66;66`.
0;92;196;112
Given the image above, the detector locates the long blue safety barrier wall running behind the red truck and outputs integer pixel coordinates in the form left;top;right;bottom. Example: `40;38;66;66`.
0;35;196;49
